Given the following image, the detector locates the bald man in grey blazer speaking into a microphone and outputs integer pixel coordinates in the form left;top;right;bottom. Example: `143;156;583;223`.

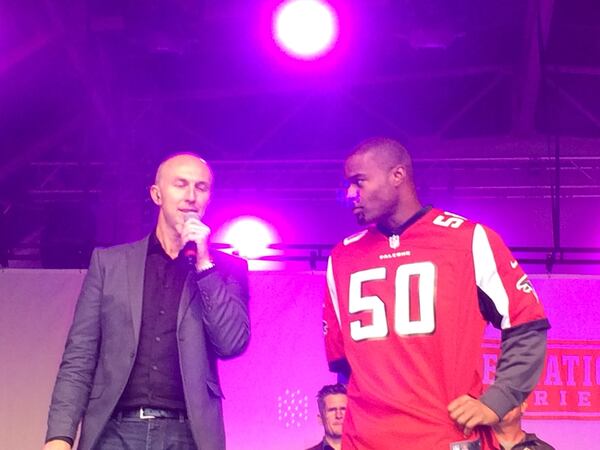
44;153;250;450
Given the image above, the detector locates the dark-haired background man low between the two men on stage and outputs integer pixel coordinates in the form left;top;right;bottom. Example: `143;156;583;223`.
308;383;348;450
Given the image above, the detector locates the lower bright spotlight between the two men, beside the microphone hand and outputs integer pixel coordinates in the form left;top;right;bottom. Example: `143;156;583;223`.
223;216;278;259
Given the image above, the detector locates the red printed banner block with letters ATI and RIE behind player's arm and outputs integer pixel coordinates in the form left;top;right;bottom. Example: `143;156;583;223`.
483;339;600;420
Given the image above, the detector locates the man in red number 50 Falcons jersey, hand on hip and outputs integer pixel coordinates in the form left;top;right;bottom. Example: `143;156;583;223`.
324;138;549;450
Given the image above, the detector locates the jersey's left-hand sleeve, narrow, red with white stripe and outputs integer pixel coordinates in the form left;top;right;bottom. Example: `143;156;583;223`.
323;256;349;375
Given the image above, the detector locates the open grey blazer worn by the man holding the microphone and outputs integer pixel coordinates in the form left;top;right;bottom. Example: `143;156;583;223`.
46;237;250;450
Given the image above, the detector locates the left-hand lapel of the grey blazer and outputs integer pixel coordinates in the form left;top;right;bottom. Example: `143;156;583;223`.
127;236;148;342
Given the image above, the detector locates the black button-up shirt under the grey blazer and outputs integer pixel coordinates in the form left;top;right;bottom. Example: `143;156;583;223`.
117;233;190;410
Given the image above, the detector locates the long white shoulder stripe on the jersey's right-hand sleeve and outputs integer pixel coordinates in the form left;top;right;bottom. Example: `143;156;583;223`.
473;224;510;330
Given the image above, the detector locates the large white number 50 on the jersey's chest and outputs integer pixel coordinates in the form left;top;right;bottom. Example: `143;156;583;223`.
349;262;436;341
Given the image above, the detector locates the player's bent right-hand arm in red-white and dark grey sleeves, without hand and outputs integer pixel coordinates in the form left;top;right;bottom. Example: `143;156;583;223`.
473;225;550;418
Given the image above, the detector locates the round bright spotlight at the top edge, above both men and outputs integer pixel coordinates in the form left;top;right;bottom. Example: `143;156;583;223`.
273;0;338;59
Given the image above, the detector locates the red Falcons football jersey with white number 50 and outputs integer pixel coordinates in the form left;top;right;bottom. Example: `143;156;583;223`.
324;209;544;450
